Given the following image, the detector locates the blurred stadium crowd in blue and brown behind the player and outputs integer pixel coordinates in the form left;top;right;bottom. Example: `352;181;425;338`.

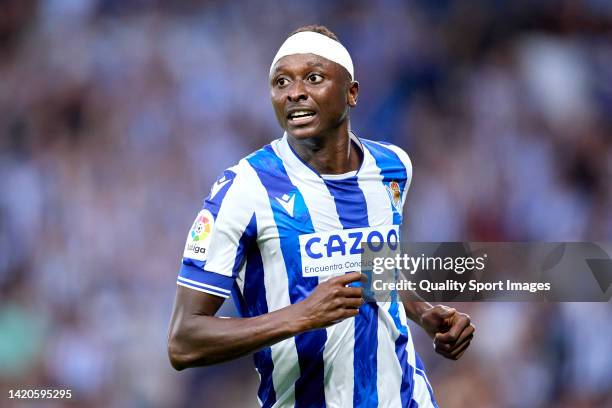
0;0;612;408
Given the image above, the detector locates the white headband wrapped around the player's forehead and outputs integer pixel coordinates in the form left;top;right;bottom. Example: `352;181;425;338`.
270;31;355;81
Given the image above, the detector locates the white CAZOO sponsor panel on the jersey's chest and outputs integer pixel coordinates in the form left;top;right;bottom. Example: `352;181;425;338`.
299;225;399;277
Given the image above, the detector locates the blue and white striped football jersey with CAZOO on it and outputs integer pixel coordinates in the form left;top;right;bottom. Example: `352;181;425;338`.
177;134;436;408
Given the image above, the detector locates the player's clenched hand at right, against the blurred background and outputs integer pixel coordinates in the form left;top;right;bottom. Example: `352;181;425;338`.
420;305;476;360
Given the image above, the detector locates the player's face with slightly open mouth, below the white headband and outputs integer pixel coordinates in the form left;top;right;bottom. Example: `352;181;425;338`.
270;54;358;139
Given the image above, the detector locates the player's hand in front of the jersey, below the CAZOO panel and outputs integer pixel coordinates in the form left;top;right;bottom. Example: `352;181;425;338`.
295;272;365;330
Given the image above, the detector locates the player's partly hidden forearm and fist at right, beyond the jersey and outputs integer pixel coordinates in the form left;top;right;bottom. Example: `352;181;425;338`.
402;293;476;360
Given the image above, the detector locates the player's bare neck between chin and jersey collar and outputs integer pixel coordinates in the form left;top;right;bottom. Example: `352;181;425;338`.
287;126;362;174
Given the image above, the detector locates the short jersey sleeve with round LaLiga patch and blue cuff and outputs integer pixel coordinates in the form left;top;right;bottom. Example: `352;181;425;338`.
177;164;257;298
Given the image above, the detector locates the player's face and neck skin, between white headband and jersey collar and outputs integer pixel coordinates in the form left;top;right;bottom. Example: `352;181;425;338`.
270;54;361;174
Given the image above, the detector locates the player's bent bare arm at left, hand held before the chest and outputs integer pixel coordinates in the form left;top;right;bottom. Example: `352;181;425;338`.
168;273;363;370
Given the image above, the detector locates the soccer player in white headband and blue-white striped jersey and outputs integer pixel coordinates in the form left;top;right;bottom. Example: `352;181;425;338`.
168;26;474;407
